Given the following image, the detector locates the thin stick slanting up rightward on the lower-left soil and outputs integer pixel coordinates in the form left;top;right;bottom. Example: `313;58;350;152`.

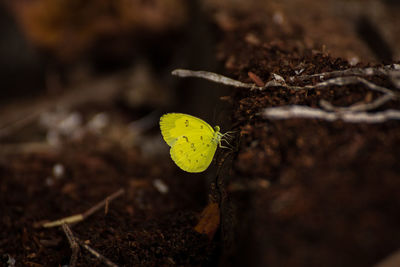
41;189;125;228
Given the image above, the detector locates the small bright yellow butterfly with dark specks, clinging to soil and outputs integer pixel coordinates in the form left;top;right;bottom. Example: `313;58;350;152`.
160;113;228;172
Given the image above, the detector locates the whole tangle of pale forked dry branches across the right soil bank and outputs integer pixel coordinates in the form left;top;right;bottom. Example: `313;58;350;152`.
172;68;400;123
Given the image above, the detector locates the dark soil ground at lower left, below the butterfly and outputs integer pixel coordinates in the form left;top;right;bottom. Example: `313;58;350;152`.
0;133;213;266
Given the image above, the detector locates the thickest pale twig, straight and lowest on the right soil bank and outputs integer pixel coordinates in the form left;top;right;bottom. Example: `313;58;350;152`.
262;105;400;123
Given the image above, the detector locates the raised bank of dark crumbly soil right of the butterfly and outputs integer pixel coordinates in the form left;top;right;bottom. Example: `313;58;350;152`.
219;1;400;266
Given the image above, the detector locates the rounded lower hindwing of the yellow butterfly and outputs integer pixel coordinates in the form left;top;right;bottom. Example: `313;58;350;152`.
170;132;217;172
